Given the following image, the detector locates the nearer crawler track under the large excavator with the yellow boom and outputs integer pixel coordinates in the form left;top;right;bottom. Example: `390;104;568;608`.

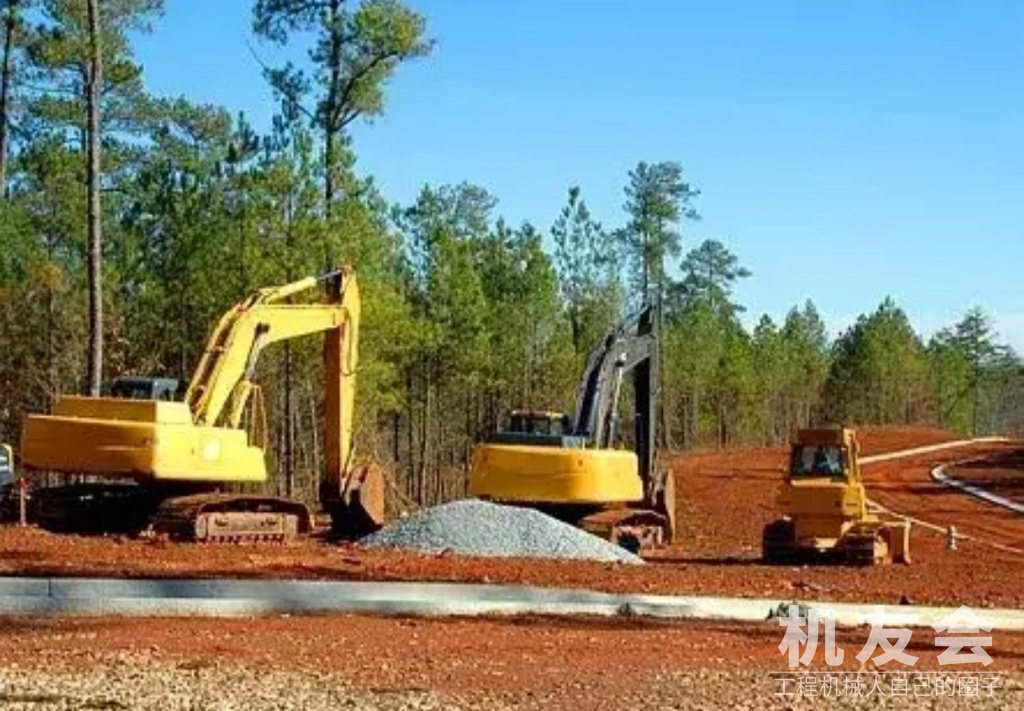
150;493;312;543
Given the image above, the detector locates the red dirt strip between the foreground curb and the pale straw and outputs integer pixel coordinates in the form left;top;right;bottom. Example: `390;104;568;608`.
0;616;1024;699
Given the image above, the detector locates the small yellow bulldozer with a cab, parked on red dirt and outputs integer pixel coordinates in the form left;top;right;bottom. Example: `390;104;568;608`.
762;427;910;566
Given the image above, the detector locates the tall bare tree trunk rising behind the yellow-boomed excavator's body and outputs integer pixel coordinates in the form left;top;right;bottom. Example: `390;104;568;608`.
86;0;103;396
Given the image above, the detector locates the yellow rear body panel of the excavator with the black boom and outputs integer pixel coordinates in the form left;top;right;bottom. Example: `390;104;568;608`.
469;444;644;504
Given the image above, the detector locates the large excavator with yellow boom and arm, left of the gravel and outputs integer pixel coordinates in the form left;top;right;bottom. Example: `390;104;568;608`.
19;266;384;542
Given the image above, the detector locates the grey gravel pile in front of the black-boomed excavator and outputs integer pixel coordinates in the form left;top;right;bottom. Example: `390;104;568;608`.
359;499;643;563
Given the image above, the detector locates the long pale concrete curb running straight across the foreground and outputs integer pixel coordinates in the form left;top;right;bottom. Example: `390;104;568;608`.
0;578;1024;631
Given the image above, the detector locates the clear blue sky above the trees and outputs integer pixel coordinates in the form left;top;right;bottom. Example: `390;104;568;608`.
138;0;1024;352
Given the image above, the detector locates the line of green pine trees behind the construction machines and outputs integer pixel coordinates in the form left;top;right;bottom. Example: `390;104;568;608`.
0;0;1024;512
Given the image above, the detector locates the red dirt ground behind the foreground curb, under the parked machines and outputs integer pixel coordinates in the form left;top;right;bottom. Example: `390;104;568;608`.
0;428;1024;608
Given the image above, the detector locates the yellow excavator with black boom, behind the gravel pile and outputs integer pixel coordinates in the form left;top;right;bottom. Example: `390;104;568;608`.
469;305;676;552
